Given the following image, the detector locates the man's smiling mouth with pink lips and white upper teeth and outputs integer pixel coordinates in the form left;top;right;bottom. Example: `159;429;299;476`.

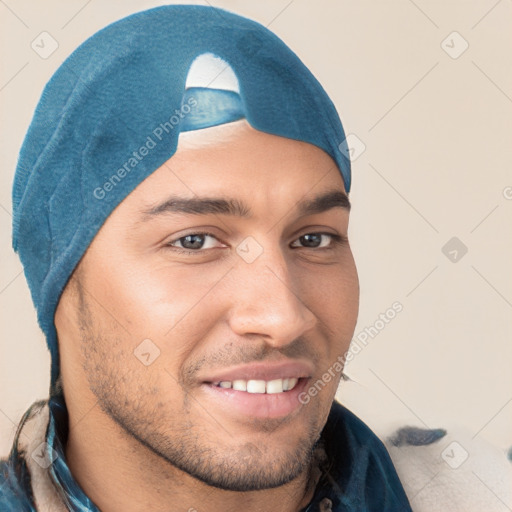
200;362;313;421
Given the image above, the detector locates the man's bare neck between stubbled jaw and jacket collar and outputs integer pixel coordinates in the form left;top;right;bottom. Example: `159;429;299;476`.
65;403;319;512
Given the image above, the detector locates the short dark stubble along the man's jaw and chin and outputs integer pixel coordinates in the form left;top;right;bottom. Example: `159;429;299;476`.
70;274;323;492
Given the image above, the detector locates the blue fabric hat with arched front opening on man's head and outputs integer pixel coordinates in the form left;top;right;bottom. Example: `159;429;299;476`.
13;5;350;392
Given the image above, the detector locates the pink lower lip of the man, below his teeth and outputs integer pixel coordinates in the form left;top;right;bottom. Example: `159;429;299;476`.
201;378;309;418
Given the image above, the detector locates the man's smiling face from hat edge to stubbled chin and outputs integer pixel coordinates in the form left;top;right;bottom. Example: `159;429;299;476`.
55;121;359;491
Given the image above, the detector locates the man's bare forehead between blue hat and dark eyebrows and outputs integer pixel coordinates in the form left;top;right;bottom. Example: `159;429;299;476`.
118;120;345;216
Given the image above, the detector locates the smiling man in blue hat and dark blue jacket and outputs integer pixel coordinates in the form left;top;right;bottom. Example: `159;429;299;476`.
0;6;410;512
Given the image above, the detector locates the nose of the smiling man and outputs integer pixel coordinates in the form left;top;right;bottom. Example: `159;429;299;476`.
228;250;317;348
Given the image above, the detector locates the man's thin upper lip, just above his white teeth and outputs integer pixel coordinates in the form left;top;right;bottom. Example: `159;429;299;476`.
201;360;313;382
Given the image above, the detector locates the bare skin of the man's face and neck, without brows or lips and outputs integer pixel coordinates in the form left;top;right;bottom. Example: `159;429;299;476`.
55;120;359;512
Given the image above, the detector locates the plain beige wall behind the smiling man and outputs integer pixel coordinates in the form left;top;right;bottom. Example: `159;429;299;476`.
0;0;512;492
